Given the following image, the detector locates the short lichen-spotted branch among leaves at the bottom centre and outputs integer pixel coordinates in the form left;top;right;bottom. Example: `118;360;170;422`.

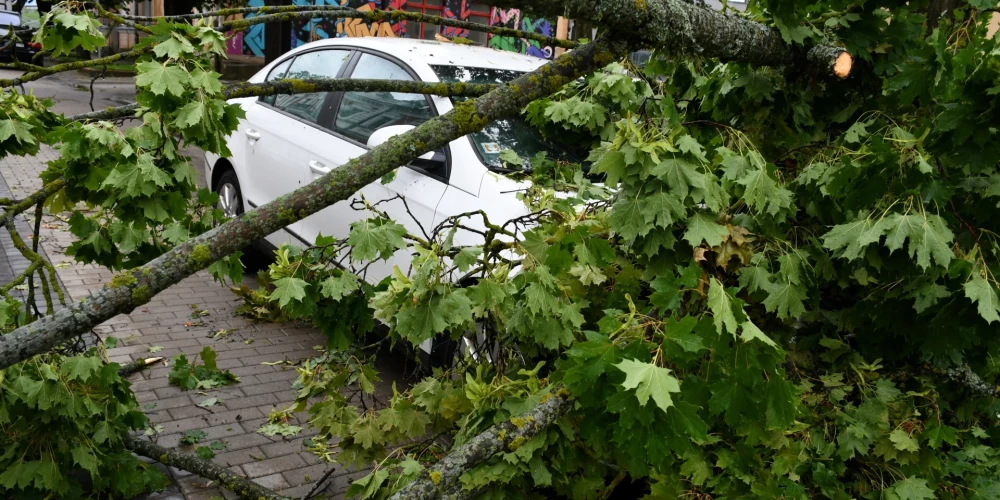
390;390;573;500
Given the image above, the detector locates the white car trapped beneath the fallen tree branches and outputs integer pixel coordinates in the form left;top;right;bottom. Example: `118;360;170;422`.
205;38;576;360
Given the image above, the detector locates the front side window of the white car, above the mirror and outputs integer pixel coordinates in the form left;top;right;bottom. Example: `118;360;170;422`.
334;53;433;144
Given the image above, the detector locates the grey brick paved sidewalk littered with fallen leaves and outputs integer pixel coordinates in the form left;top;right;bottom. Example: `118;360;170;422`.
0;147;381;500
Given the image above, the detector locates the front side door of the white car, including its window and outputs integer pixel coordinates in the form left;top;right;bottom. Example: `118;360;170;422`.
302;52;447;283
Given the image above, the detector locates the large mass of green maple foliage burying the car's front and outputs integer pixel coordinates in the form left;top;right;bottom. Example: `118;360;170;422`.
250;0;1000;499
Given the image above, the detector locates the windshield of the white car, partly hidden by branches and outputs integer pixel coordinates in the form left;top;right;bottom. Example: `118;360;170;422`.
432;66;580;167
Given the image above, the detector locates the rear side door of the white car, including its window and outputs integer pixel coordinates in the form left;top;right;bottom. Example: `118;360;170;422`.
243;49;351;245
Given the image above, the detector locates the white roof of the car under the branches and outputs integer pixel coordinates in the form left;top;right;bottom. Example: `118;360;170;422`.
286;37;548;72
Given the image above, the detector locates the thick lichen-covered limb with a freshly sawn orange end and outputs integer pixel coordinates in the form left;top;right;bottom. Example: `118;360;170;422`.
493;0;853;78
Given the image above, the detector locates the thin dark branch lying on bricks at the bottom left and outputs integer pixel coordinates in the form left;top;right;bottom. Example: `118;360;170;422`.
125;436;289;500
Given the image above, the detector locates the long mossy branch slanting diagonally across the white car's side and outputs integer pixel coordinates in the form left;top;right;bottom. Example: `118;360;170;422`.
0;39;626;368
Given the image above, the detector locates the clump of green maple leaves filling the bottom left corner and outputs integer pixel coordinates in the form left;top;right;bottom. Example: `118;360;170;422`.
0;350;167;499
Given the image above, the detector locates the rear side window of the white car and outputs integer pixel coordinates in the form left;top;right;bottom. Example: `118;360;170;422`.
274;50;351;123
